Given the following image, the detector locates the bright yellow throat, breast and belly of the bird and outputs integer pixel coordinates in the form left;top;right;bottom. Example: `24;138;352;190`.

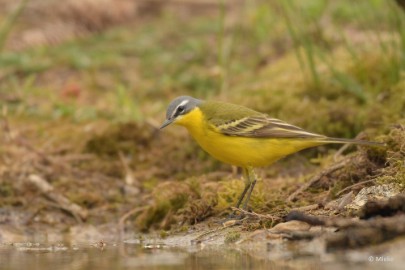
175;107;322;167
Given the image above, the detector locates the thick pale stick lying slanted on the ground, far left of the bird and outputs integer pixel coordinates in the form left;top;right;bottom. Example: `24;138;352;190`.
28;174;88;221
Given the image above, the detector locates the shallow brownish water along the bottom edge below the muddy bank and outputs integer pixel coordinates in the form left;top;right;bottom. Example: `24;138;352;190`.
0;238;403;270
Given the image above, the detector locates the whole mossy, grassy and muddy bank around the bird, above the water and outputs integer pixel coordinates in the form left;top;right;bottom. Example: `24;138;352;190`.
0;0;405;262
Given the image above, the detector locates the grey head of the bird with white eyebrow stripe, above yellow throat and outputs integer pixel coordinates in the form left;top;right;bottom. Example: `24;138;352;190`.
160;96;202;129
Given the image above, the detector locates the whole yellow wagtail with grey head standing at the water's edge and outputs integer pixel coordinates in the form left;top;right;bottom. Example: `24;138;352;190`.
160;96;382;210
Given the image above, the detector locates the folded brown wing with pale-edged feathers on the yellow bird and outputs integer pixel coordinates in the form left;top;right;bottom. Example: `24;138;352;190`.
216;117;325;139
